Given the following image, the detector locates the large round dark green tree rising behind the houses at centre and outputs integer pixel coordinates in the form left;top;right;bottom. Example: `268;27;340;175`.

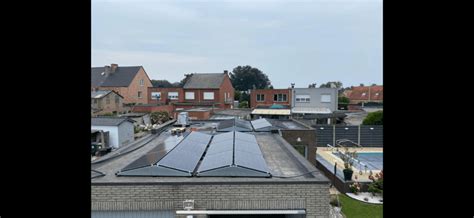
230;65;271;91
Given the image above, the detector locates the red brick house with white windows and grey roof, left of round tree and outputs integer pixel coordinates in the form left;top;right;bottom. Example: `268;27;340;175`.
148;71;234;109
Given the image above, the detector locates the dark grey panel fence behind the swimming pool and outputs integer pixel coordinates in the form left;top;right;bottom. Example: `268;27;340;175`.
314;125;383;147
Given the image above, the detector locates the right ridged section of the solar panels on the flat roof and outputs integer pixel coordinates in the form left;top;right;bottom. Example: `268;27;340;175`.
196;132;271;177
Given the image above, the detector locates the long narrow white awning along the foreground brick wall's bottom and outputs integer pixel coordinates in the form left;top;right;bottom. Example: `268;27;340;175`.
176;210;306;215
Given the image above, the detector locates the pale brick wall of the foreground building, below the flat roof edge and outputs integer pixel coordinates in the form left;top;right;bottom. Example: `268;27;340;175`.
91;183;329;218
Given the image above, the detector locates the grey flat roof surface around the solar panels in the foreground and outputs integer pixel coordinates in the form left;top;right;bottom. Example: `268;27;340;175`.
91;131;329;185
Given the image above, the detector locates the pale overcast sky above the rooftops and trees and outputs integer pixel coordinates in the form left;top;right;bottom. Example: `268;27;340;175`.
91;0;383;88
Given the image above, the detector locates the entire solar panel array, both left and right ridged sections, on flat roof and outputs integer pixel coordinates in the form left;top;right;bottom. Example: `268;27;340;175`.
116;131;271;177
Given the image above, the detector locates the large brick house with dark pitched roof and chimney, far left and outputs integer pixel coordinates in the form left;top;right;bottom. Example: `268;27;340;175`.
91;64;153;104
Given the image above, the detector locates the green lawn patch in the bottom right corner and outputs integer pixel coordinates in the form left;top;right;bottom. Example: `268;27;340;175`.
339;195;383;218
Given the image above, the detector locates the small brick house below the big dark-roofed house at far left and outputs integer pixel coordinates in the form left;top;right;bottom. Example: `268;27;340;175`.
91;90;123;115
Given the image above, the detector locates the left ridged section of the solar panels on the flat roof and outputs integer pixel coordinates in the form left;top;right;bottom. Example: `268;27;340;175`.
117;132;212;176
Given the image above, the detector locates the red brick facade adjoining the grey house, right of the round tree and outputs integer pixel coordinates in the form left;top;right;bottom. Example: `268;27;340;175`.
250;89;291;108
